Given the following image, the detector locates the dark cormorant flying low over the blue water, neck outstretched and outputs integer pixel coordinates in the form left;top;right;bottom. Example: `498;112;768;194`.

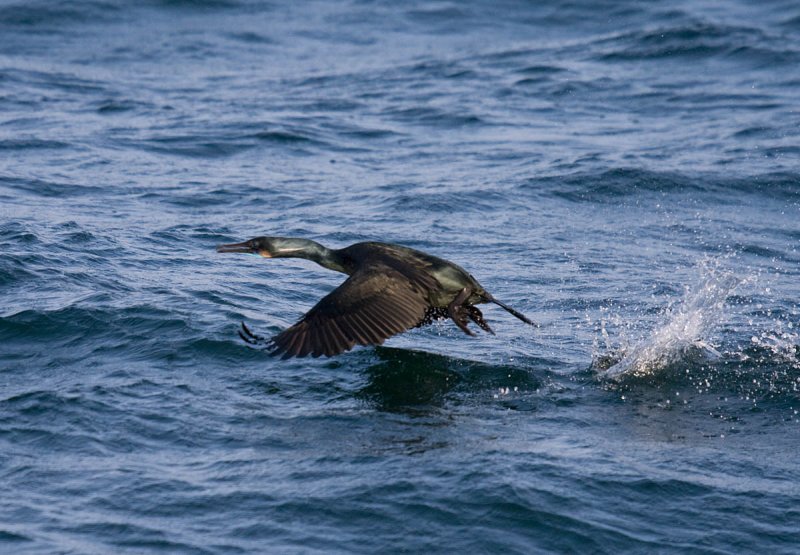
217;237;536;358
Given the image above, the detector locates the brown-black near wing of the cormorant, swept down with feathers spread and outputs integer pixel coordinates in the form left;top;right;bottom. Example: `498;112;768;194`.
271;263;429;358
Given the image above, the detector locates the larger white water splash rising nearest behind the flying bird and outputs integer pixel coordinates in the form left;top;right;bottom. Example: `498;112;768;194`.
593;260;747;379
